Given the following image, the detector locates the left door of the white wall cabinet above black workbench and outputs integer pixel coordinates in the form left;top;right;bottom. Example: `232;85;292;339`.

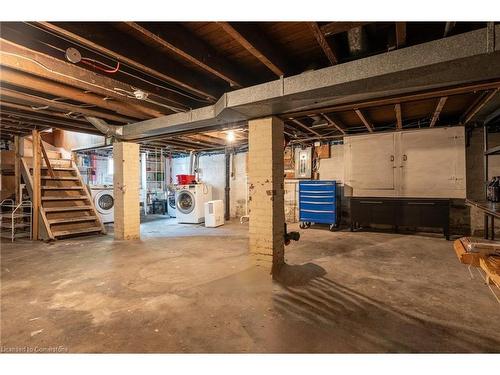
345;133;396;196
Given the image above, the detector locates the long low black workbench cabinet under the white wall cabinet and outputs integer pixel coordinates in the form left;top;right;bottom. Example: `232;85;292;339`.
350;197;450;240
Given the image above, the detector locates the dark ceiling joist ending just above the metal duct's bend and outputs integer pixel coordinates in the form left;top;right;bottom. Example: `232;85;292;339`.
125;22;247;88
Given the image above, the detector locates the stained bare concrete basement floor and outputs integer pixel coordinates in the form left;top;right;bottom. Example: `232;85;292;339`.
1;217;500;353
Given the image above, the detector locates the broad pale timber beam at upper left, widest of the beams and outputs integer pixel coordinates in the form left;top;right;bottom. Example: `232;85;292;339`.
0;38;170;117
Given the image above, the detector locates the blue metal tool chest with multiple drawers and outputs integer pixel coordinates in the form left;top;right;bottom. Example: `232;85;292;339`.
299;180;338;230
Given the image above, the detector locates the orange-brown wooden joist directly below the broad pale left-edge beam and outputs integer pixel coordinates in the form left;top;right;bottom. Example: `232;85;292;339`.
0;68;151;120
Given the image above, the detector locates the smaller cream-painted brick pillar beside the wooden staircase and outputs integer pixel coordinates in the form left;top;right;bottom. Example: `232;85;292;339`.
113;142;141;240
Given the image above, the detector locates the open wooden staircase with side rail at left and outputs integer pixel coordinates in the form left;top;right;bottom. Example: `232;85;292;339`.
21;142;106;240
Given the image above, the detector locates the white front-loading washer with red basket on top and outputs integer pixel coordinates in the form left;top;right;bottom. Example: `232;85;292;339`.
175;184;212;224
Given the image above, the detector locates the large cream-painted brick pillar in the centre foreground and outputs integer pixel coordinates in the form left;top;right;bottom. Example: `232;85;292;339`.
248;117;285;272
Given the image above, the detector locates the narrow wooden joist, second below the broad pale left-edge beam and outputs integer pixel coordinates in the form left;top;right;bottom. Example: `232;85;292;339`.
1;87;134;123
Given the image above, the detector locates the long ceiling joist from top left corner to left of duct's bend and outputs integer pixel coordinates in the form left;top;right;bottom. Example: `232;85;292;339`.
38;22;218;101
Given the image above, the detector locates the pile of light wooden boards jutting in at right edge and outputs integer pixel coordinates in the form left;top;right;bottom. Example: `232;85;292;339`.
453;237;500;288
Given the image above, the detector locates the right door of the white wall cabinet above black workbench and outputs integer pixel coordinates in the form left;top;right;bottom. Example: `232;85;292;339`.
397;127;465;198
